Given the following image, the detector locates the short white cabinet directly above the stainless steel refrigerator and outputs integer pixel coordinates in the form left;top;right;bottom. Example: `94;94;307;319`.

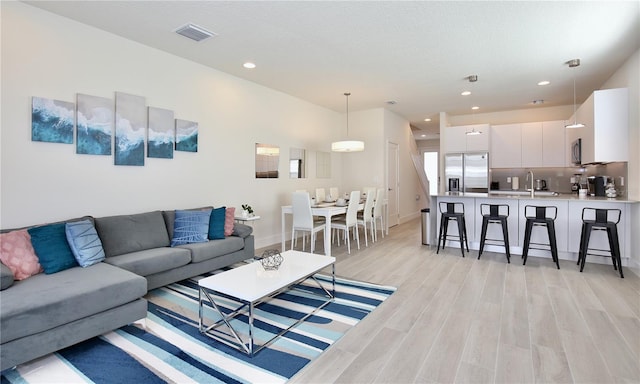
440;124;490;153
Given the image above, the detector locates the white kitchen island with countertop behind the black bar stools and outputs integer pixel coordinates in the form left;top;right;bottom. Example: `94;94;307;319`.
430;191;638;266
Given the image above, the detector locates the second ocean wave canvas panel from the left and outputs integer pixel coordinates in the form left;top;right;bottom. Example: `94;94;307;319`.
76;93;114;155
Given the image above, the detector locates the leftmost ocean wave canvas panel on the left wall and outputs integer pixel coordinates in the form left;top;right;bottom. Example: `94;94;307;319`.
31;97;76;144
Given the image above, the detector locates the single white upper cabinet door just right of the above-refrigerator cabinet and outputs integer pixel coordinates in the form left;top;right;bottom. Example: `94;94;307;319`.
489;124;522;168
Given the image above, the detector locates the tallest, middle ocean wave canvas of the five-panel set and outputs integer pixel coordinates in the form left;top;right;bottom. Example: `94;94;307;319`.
114;92;147;166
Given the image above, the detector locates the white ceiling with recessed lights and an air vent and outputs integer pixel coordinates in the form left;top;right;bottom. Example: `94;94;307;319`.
24;0;640;137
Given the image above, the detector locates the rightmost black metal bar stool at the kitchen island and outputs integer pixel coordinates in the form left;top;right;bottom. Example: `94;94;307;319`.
578;207;624;278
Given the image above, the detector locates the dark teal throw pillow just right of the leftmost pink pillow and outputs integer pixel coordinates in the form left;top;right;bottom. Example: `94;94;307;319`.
28;223;78;275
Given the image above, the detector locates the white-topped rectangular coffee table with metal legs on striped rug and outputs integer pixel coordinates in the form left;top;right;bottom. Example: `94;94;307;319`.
198;250;336;356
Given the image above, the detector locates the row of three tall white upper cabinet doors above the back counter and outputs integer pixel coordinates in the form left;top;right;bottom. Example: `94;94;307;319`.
491;120;565;168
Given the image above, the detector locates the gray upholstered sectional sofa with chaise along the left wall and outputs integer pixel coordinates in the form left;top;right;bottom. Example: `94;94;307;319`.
0;211;255;370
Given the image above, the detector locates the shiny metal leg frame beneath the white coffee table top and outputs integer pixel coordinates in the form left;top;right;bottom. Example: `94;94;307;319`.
198;265;336;357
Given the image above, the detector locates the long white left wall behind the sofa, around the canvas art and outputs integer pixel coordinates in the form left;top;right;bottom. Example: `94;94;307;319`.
0;1;343;246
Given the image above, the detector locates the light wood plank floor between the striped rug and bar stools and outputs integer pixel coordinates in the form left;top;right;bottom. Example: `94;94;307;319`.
262;220;640;383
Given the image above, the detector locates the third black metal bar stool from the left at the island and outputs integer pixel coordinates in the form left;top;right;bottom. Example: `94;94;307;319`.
522;205;560;269
